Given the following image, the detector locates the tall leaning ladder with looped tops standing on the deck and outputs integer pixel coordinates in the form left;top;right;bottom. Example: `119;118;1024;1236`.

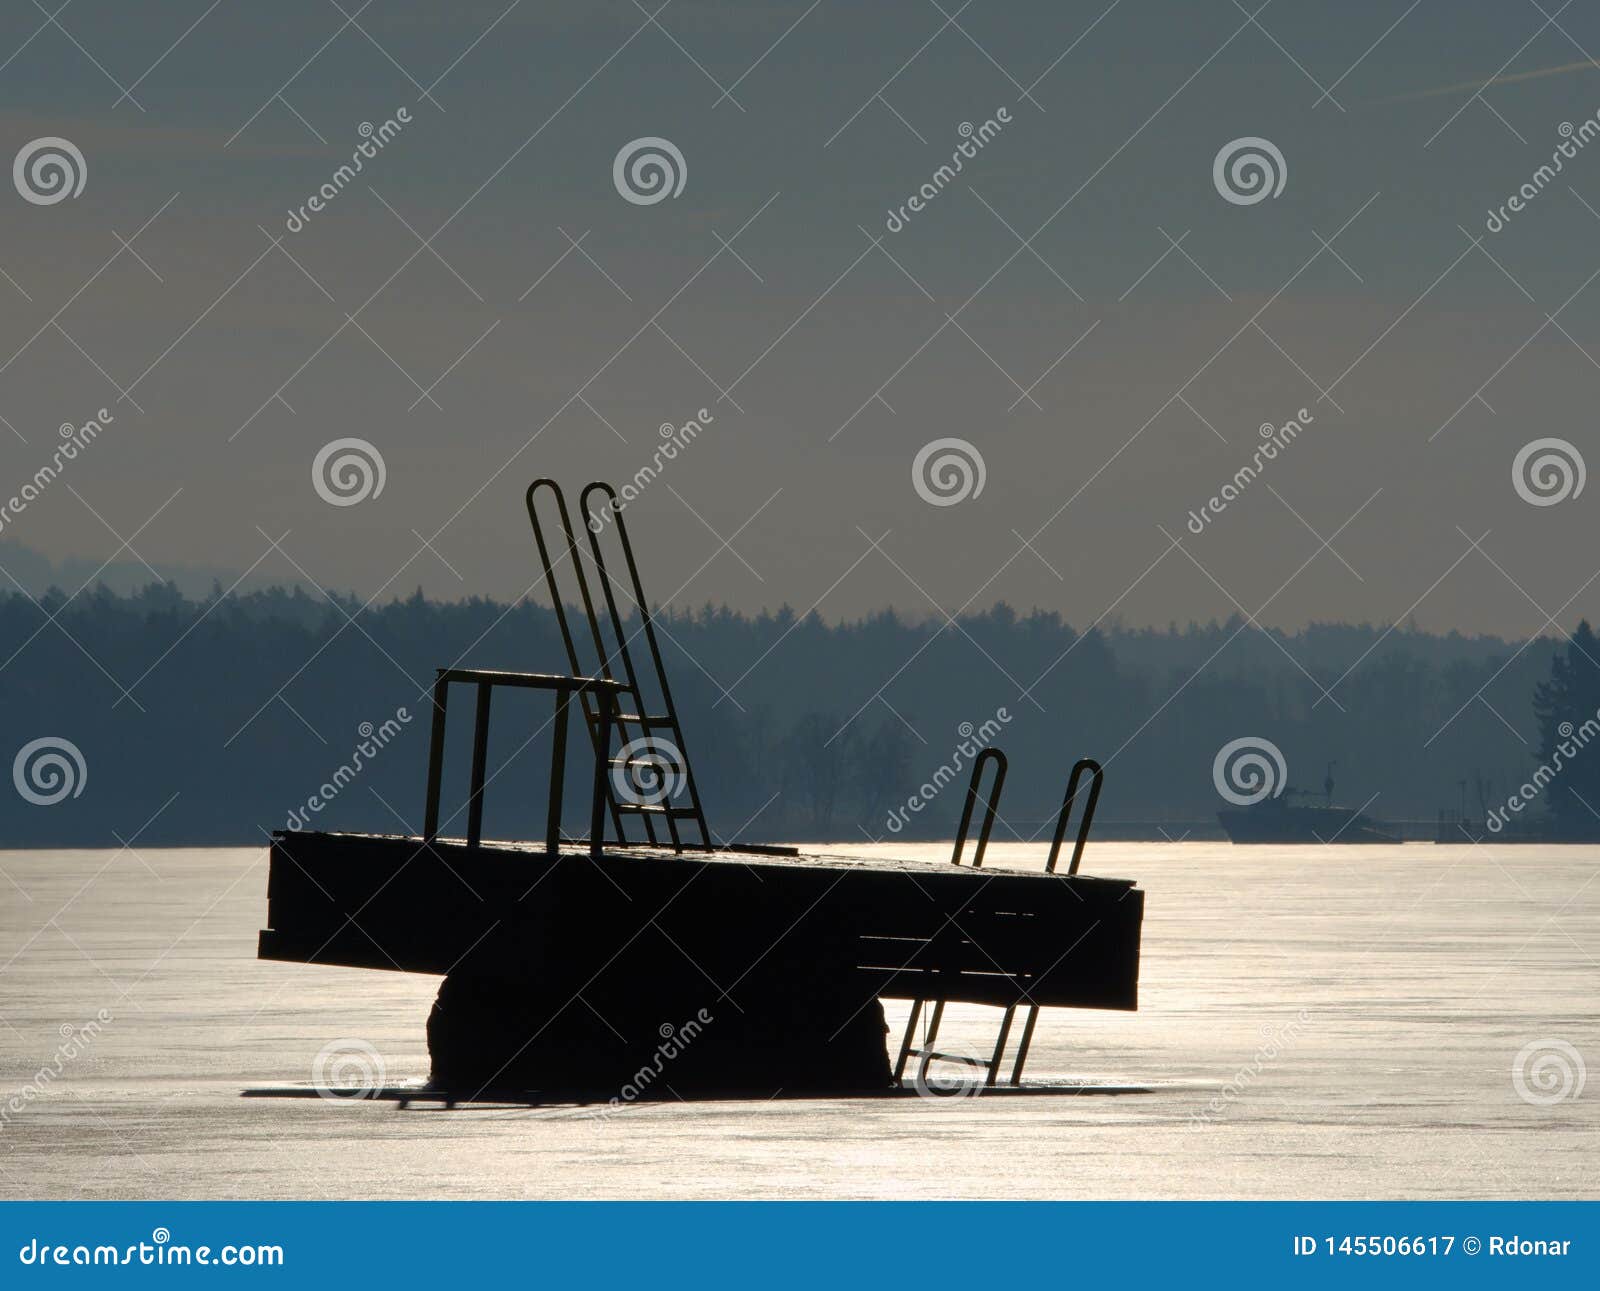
526;478;715;851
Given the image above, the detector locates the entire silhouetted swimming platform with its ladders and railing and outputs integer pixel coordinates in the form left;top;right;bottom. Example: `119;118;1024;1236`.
259;480;1144;1097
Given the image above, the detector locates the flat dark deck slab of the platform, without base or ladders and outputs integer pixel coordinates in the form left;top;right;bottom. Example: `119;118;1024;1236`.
259;832;1144;1009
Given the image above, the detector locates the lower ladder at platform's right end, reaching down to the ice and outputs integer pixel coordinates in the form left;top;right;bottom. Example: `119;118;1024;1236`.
894;749;1106;1088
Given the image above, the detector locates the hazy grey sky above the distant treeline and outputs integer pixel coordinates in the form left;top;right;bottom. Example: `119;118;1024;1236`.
0;0;1600;635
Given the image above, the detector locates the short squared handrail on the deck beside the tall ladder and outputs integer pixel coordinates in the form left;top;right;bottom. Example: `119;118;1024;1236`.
422;669;624;856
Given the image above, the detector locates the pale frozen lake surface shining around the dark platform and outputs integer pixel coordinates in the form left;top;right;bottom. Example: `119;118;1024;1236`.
0;843;1600;1198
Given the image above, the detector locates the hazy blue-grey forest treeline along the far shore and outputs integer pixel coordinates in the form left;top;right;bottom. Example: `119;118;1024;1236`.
0;586;1574;846
